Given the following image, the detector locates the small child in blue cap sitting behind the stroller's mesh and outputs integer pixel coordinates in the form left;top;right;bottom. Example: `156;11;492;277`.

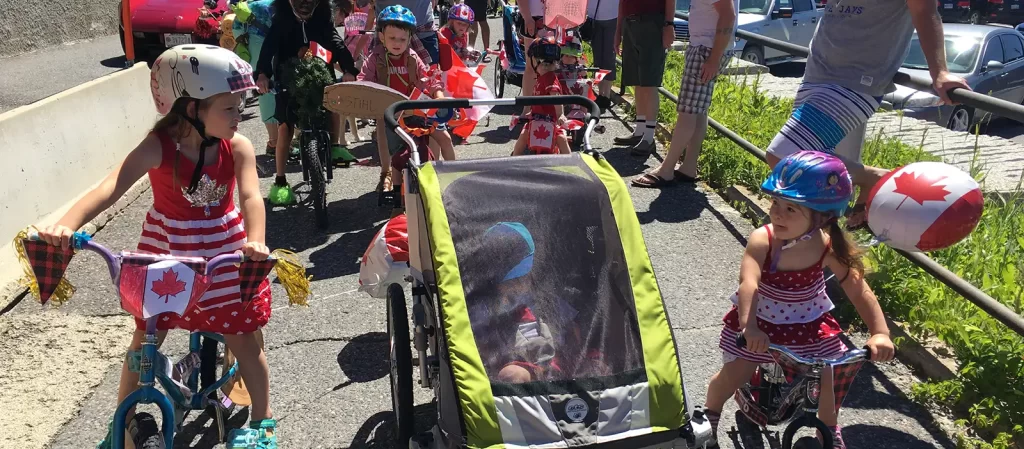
467;221;611;383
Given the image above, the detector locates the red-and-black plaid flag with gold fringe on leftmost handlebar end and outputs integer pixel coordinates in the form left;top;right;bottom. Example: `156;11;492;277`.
14;230;75;305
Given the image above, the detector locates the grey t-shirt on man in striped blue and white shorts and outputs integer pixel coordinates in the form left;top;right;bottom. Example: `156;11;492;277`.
804;0;913;96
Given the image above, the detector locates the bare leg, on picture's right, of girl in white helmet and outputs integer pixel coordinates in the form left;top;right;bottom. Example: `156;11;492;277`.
224;332;273;421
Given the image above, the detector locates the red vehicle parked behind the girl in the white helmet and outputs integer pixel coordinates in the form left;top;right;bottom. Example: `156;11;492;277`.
118;0;228;60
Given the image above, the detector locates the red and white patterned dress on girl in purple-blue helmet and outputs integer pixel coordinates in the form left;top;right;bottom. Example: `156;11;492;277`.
719;225;847;363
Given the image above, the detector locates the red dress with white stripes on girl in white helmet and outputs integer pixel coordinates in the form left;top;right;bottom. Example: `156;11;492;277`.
135;131;270;334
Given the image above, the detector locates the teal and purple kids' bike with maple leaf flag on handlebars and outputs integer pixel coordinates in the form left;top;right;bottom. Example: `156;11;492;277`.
23;232;288;449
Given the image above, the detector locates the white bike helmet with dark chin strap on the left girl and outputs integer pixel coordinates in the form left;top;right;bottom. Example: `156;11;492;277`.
150;44;256;192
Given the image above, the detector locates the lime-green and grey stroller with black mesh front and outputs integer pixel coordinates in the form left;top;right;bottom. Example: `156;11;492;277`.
384;95;711;449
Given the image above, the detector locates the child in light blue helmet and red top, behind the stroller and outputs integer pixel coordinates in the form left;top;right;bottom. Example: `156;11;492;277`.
358;5;455;192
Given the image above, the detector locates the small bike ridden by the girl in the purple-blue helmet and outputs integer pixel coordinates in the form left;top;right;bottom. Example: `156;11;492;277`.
729;334;870;449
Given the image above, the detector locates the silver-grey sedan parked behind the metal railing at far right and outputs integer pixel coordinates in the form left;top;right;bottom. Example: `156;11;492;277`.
882;24;1024;131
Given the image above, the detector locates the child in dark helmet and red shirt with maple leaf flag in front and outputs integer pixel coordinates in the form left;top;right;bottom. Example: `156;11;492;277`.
512;37;569;156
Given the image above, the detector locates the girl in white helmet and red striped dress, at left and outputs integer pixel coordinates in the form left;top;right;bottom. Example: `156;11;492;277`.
39;45;278;449
